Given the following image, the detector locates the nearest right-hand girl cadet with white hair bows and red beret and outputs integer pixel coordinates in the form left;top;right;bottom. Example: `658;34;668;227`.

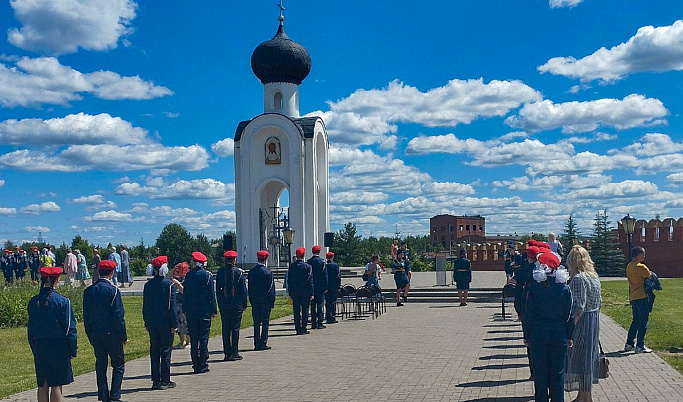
522;250;574;402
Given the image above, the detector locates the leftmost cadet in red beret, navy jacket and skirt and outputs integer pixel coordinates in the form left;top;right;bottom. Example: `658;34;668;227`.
28;267;77;402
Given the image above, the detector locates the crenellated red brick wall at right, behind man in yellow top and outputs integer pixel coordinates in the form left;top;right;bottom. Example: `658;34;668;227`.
617;218;683;278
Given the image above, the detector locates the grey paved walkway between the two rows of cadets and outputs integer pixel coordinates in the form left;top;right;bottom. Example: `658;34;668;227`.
10;273;683;402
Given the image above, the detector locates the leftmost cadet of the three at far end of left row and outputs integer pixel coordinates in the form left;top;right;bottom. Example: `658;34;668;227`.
287;247;313;335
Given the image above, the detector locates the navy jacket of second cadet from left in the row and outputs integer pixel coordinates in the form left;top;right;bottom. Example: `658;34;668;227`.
83;278;128;342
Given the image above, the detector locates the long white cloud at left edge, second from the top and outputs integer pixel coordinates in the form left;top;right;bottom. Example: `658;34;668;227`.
0;57;173;108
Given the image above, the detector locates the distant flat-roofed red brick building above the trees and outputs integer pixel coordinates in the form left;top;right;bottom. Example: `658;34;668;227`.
429;215;486;250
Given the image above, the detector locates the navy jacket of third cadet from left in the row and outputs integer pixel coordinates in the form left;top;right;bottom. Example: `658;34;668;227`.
142;275;178;330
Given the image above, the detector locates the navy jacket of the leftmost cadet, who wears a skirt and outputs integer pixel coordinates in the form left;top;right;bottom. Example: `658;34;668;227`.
28;288;78;357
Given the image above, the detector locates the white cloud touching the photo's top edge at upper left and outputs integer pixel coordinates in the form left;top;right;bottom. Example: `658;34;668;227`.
7;0;137;54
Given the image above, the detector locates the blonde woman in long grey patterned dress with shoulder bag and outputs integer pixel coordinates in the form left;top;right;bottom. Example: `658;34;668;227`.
564;245;602;402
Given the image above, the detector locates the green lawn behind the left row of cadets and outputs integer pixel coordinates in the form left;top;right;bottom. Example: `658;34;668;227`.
0;296;292;398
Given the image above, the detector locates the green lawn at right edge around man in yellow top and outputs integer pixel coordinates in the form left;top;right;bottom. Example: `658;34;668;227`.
602;278;683;373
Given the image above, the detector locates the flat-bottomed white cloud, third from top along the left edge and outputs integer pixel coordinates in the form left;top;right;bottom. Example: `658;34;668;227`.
0;113;153;146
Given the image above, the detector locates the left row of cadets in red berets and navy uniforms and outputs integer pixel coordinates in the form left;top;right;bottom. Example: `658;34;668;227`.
28;246;341;402
